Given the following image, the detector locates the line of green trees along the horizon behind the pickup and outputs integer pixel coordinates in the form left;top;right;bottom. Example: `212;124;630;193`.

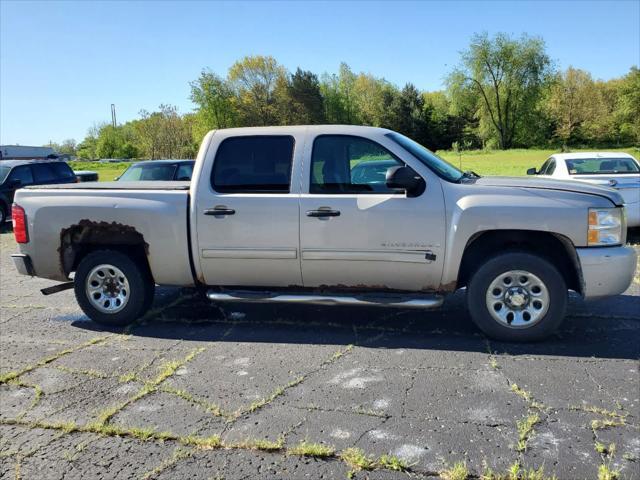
53;34;640;159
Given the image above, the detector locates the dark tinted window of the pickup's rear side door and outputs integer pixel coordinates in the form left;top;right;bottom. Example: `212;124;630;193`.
211;135;295;193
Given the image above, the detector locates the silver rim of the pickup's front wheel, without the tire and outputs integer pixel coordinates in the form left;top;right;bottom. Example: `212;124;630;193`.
486;270;550;328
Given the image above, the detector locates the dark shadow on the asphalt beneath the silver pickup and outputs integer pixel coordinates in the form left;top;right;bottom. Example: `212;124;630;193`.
73;289;640;359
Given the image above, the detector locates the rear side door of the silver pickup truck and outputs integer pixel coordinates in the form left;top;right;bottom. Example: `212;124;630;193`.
195;131;304;287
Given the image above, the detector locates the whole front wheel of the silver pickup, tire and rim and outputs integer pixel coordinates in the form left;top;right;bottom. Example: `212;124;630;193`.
467;252;567;342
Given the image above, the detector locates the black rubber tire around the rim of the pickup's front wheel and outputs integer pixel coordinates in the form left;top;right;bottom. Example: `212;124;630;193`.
467;252;568;342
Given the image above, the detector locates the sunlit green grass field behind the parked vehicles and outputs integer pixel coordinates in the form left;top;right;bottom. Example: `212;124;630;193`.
69;147;640;182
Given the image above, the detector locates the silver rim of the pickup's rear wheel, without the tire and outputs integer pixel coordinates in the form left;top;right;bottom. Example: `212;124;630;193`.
85;264;130;313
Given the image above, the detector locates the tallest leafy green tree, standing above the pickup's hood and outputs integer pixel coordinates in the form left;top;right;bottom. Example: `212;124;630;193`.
447;33;552;148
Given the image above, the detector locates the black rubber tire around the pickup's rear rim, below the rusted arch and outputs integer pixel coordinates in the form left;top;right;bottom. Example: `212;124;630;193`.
74;250;155;326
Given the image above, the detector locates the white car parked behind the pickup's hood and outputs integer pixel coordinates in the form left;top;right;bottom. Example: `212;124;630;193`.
527;152;640;227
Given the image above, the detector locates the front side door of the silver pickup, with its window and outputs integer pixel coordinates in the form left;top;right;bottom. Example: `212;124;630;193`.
300;135;445;291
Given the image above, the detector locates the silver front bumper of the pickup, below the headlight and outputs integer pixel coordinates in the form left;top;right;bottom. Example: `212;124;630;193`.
576;246;637;300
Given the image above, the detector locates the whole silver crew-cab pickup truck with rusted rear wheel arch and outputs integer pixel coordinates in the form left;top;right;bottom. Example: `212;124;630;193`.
12;126;636;341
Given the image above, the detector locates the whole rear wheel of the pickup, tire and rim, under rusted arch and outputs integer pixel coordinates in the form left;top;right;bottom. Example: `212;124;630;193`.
74;250;155;326
